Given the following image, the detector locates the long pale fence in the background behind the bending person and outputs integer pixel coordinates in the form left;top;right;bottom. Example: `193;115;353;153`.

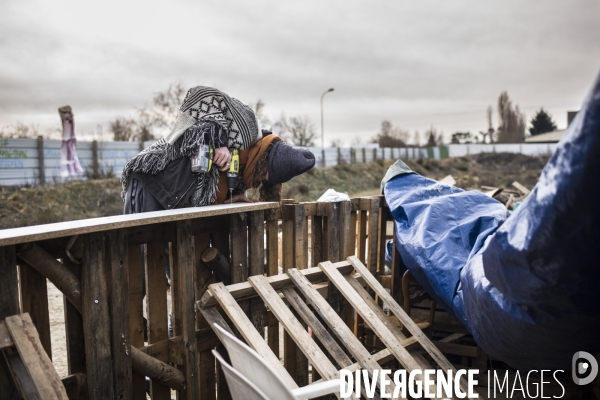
0;139;556;185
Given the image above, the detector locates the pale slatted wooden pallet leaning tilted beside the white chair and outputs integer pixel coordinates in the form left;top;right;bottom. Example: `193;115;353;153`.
197;256;476;400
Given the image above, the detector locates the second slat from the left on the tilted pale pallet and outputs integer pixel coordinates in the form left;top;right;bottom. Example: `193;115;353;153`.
248;276;339;380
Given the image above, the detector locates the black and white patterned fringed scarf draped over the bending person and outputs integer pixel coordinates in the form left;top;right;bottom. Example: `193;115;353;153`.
121;86;258;207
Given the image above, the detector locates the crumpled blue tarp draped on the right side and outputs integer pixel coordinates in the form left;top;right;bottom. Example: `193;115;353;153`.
382;71;600;369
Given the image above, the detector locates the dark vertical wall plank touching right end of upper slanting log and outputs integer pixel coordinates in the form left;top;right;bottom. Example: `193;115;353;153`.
81;233;114;400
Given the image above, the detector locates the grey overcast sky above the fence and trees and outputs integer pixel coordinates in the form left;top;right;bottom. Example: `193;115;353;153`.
0;0;600;145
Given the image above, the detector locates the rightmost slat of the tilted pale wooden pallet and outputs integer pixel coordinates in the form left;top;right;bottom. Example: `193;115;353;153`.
344;256;467;392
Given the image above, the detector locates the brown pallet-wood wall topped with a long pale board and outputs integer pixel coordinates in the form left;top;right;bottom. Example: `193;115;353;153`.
0;196;482;400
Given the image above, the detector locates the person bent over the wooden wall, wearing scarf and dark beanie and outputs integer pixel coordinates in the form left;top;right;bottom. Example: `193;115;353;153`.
121;86;315;214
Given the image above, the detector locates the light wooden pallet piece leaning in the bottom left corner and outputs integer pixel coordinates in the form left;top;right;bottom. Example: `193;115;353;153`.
0;313;68;400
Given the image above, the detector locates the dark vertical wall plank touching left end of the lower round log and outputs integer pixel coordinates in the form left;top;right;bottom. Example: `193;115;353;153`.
107;229;133;400
